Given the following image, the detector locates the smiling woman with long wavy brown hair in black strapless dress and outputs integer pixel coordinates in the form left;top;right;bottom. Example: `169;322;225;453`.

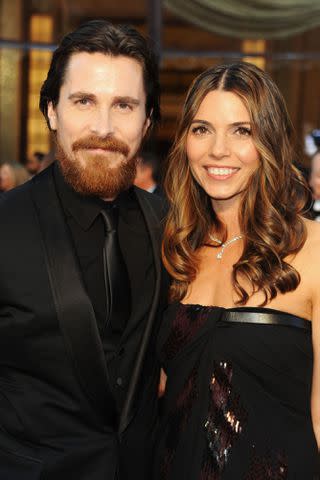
155;63;320;480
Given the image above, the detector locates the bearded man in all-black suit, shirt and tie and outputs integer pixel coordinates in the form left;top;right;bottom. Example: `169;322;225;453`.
0;20;166;480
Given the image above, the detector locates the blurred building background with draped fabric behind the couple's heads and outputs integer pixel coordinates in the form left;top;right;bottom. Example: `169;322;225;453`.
0;0;320;186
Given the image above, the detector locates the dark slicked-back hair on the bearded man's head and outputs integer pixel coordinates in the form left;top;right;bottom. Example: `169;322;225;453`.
39;20;160;129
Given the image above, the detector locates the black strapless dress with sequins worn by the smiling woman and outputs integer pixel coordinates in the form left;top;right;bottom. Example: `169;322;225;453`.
154;303;320;480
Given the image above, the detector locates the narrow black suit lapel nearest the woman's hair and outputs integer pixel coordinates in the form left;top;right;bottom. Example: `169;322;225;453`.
119;189;161;435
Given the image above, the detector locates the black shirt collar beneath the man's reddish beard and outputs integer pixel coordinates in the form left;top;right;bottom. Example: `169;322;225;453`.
54;162;134;230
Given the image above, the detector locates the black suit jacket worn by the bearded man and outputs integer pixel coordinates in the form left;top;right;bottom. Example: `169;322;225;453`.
0;163;167;480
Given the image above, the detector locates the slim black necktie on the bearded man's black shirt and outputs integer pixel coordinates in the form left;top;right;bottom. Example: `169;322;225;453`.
101;205;131;336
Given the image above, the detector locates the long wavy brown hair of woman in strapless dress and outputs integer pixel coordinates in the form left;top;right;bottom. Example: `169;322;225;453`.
162;62;310;306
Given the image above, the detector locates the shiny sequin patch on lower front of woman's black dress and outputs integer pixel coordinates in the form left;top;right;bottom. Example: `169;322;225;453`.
201;361;247;480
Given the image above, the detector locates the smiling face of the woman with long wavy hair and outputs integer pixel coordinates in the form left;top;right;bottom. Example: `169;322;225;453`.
186;90;259;210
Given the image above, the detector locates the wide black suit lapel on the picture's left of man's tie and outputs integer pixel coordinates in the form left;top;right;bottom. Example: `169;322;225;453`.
31;168;116;425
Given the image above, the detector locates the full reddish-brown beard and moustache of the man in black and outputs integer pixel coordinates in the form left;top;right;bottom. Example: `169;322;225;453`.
56;135;137;199
